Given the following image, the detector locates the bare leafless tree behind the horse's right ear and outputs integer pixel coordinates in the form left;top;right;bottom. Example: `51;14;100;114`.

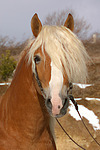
44;9;90;40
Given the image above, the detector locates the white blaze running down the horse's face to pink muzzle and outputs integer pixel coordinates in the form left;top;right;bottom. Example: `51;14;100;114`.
49;62;63;115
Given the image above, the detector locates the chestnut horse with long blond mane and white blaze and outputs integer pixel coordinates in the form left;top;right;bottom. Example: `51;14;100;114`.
0;14;88;150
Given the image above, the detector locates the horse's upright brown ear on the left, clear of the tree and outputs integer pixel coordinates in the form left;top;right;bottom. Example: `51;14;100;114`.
31;14;42;37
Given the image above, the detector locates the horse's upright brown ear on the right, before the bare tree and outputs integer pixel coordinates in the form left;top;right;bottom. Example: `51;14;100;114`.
64;14;74;31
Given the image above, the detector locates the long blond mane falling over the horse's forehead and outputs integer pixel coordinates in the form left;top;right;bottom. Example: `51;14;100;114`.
29;26;89;83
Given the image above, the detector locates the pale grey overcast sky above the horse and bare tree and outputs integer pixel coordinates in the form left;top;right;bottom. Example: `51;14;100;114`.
0;0;100;41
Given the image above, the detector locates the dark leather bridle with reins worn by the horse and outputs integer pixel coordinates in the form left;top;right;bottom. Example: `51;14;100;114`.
33;56;100;150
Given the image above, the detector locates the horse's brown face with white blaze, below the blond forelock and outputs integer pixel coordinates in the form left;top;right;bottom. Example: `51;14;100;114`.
33;47;69;117
